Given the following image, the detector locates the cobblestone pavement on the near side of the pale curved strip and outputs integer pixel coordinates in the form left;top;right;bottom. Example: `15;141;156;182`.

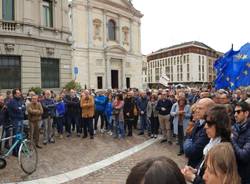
65;142;186;184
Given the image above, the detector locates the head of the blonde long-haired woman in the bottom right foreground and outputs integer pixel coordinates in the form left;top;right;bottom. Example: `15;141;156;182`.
203;143;240;184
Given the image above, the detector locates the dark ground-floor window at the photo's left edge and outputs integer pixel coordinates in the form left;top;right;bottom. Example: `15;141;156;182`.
0;56;21;89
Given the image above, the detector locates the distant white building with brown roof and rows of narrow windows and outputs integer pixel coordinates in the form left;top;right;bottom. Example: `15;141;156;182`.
147;41;221;86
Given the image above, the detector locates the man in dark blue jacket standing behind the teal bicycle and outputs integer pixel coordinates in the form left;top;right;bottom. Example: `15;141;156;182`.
7;89;26;156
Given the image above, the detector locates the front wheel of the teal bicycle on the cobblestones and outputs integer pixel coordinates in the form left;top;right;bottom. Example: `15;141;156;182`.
18;139;38;174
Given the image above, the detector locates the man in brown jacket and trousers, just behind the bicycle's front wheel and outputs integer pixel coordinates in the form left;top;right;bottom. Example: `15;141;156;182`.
27;94;43;149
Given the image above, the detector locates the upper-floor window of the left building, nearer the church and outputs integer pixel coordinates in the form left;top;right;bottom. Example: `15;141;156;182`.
43;0;53;27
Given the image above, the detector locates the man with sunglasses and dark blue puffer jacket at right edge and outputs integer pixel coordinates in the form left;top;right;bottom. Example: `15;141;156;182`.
231;101;250;184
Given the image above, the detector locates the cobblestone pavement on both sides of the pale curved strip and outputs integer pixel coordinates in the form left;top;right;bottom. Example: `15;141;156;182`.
0;130;186;184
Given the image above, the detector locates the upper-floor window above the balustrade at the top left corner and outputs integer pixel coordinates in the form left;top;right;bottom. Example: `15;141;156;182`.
2;0;15;21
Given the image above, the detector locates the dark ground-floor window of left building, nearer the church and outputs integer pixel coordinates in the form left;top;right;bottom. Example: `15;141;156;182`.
41;58;60;88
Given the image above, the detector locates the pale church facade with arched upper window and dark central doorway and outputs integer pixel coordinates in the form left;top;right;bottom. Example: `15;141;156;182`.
70;0;143;89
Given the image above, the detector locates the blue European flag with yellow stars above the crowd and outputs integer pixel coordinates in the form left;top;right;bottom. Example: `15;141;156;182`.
214;43;250;90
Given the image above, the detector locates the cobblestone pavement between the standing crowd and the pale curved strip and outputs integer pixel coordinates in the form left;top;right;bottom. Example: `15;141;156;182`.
0;130;148;183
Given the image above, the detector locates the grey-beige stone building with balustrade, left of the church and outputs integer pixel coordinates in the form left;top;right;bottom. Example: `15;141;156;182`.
0;0;72;91
